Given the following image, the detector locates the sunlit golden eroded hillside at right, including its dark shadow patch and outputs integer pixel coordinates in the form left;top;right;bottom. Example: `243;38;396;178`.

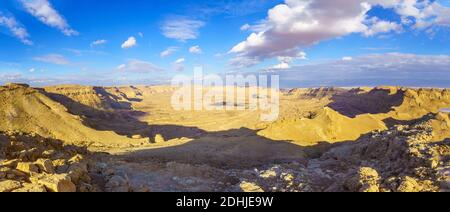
259;87;450;145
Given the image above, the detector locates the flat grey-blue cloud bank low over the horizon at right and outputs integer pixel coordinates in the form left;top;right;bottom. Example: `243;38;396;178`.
276;53;450;87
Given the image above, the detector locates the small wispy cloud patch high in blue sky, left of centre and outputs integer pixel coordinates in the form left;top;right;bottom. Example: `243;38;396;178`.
161;17;205;42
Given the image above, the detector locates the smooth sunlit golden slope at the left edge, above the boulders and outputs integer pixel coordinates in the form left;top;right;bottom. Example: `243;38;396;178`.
0;84;149;146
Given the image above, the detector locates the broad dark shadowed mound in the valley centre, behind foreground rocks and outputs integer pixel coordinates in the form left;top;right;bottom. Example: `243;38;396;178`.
114;128;354;169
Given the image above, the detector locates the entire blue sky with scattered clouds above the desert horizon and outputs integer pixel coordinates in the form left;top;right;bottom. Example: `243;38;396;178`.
0;0;450;87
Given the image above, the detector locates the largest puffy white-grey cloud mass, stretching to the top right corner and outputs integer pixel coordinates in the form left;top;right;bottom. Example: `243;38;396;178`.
229;0;450;65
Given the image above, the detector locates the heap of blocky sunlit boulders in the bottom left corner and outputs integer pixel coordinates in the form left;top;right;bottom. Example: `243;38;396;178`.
0;132;148;192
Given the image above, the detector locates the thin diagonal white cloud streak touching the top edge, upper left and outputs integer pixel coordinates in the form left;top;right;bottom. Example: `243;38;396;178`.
20;0;78;36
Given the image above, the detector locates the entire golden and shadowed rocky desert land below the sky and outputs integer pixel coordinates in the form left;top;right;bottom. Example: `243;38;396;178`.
0;84;450;192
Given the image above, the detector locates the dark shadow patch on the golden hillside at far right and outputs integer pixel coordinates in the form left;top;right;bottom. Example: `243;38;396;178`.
327;88;404;118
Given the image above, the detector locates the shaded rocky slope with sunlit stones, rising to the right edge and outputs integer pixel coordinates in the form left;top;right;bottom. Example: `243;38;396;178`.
245;113;450;192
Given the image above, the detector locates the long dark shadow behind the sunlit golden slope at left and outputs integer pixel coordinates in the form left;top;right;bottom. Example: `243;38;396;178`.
44;91;205;139
